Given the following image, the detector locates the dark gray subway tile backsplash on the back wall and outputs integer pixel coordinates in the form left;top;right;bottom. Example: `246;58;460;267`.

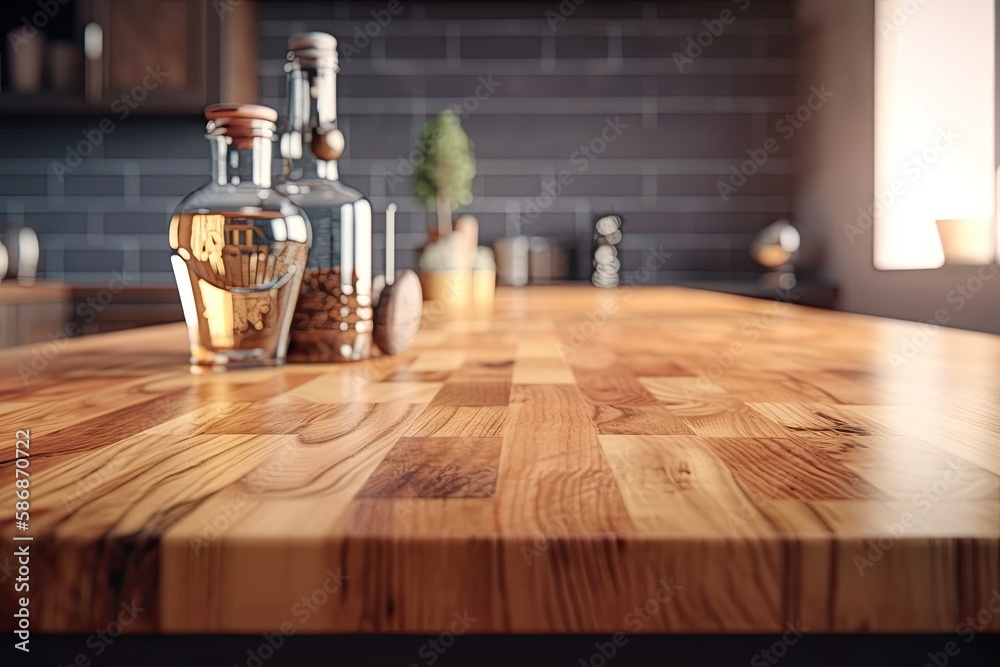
0;0;796;284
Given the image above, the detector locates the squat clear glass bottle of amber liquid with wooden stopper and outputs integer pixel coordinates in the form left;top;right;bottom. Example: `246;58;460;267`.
169;104;311;366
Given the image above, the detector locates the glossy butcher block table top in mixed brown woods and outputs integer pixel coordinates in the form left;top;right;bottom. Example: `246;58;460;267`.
0;287;1000;633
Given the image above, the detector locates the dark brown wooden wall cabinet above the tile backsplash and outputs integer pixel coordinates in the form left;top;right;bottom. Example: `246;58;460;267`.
0;0;258;116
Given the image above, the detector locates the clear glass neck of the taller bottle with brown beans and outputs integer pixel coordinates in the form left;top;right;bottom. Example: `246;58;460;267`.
281;60;340;181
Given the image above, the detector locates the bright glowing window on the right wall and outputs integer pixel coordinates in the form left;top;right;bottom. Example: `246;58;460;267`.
872;0;996;269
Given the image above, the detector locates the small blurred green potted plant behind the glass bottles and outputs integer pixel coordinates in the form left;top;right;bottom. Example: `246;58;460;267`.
415;109;479;310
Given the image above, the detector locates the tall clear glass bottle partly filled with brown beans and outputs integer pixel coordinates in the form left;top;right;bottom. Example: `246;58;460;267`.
279;32;374;362
